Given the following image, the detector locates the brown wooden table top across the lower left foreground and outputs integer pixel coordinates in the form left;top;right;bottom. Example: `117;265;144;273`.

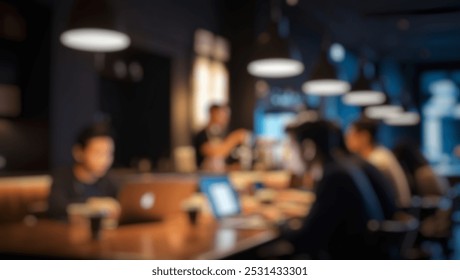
0;214;277;259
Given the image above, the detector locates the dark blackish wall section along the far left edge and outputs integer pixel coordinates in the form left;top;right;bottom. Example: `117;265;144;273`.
0;1;52;171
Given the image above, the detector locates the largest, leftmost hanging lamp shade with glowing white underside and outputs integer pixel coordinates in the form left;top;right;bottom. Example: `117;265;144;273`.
60;0;131;52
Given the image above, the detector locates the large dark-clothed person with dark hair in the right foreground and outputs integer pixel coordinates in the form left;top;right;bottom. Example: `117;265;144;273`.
286;118;396;259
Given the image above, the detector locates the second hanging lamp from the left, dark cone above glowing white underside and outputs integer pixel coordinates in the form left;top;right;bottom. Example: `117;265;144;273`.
247;21;304;78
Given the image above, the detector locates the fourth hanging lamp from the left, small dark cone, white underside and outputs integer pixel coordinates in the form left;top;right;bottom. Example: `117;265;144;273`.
342;63;386;106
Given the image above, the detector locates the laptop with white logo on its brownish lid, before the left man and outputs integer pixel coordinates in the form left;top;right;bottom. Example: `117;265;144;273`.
118;180;196;225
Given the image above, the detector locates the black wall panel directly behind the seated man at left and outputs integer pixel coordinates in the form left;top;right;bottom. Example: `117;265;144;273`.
99;50;171;167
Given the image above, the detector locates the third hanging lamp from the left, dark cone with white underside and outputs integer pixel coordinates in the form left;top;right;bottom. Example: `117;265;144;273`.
302;48;350;96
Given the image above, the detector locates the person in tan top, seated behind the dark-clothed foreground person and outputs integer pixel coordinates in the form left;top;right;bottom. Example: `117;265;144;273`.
346;119;411;208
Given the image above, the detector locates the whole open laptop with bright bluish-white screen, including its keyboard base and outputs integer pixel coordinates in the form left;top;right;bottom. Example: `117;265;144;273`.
199;176;270;229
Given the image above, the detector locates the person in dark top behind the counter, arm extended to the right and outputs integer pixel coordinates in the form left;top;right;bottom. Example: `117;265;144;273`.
193;104;250;171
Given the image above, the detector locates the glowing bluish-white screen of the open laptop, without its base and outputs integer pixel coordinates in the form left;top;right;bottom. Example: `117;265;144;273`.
200;176;241;219
